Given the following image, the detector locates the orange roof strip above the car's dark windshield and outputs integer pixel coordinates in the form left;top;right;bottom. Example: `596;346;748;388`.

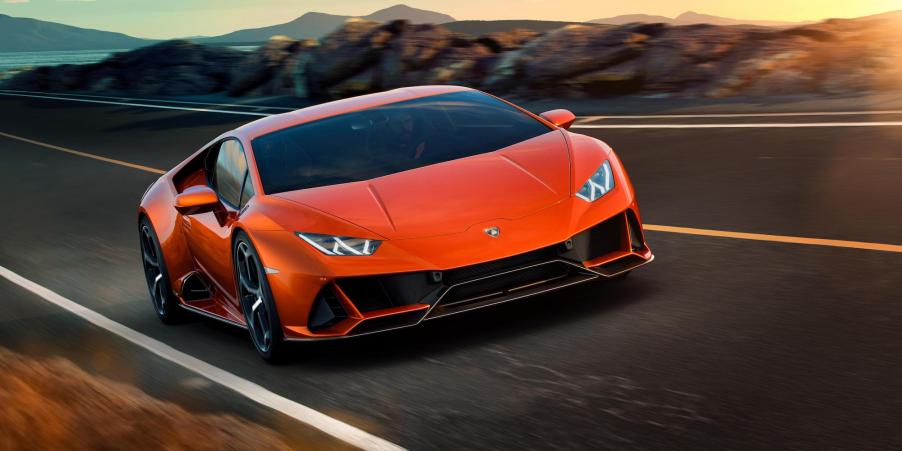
232;86;475;141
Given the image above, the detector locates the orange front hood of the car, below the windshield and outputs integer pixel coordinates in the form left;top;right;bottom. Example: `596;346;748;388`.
274;131;571;239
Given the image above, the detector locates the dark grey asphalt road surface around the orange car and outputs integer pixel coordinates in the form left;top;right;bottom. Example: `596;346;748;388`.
0;96;902;450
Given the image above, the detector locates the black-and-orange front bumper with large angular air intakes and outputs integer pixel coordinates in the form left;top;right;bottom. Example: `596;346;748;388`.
285;210;654;340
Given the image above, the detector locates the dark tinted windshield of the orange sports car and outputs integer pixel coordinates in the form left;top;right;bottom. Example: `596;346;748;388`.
252;91;551;193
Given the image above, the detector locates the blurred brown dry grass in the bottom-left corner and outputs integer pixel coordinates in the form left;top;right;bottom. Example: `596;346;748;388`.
0;348;298;451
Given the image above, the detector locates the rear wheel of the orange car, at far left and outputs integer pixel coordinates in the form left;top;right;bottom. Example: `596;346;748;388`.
138;217;182;324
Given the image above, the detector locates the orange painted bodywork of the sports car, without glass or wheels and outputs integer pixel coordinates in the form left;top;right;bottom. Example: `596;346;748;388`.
139;86;652;339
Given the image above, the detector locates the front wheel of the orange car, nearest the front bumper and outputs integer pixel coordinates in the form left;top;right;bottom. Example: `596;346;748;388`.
232;232;286;363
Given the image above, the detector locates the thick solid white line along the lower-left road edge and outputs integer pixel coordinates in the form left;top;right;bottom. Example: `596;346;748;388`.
0;266;404;450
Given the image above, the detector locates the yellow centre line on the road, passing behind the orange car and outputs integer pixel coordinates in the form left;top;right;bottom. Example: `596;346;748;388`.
0;132;902;253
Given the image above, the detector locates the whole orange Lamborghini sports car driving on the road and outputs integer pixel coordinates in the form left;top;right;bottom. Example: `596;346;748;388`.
138;86;653;360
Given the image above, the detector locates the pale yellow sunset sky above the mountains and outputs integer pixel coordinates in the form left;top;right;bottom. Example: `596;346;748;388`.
0;0;902;38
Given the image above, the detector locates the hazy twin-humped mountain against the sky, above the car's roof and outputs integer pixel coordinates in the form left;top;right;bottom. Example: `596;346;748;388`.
194;5;454;44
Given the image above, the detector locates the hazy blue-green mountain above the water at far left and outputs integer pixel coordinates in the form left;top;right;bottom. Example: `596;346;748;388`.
0;14;156;52
